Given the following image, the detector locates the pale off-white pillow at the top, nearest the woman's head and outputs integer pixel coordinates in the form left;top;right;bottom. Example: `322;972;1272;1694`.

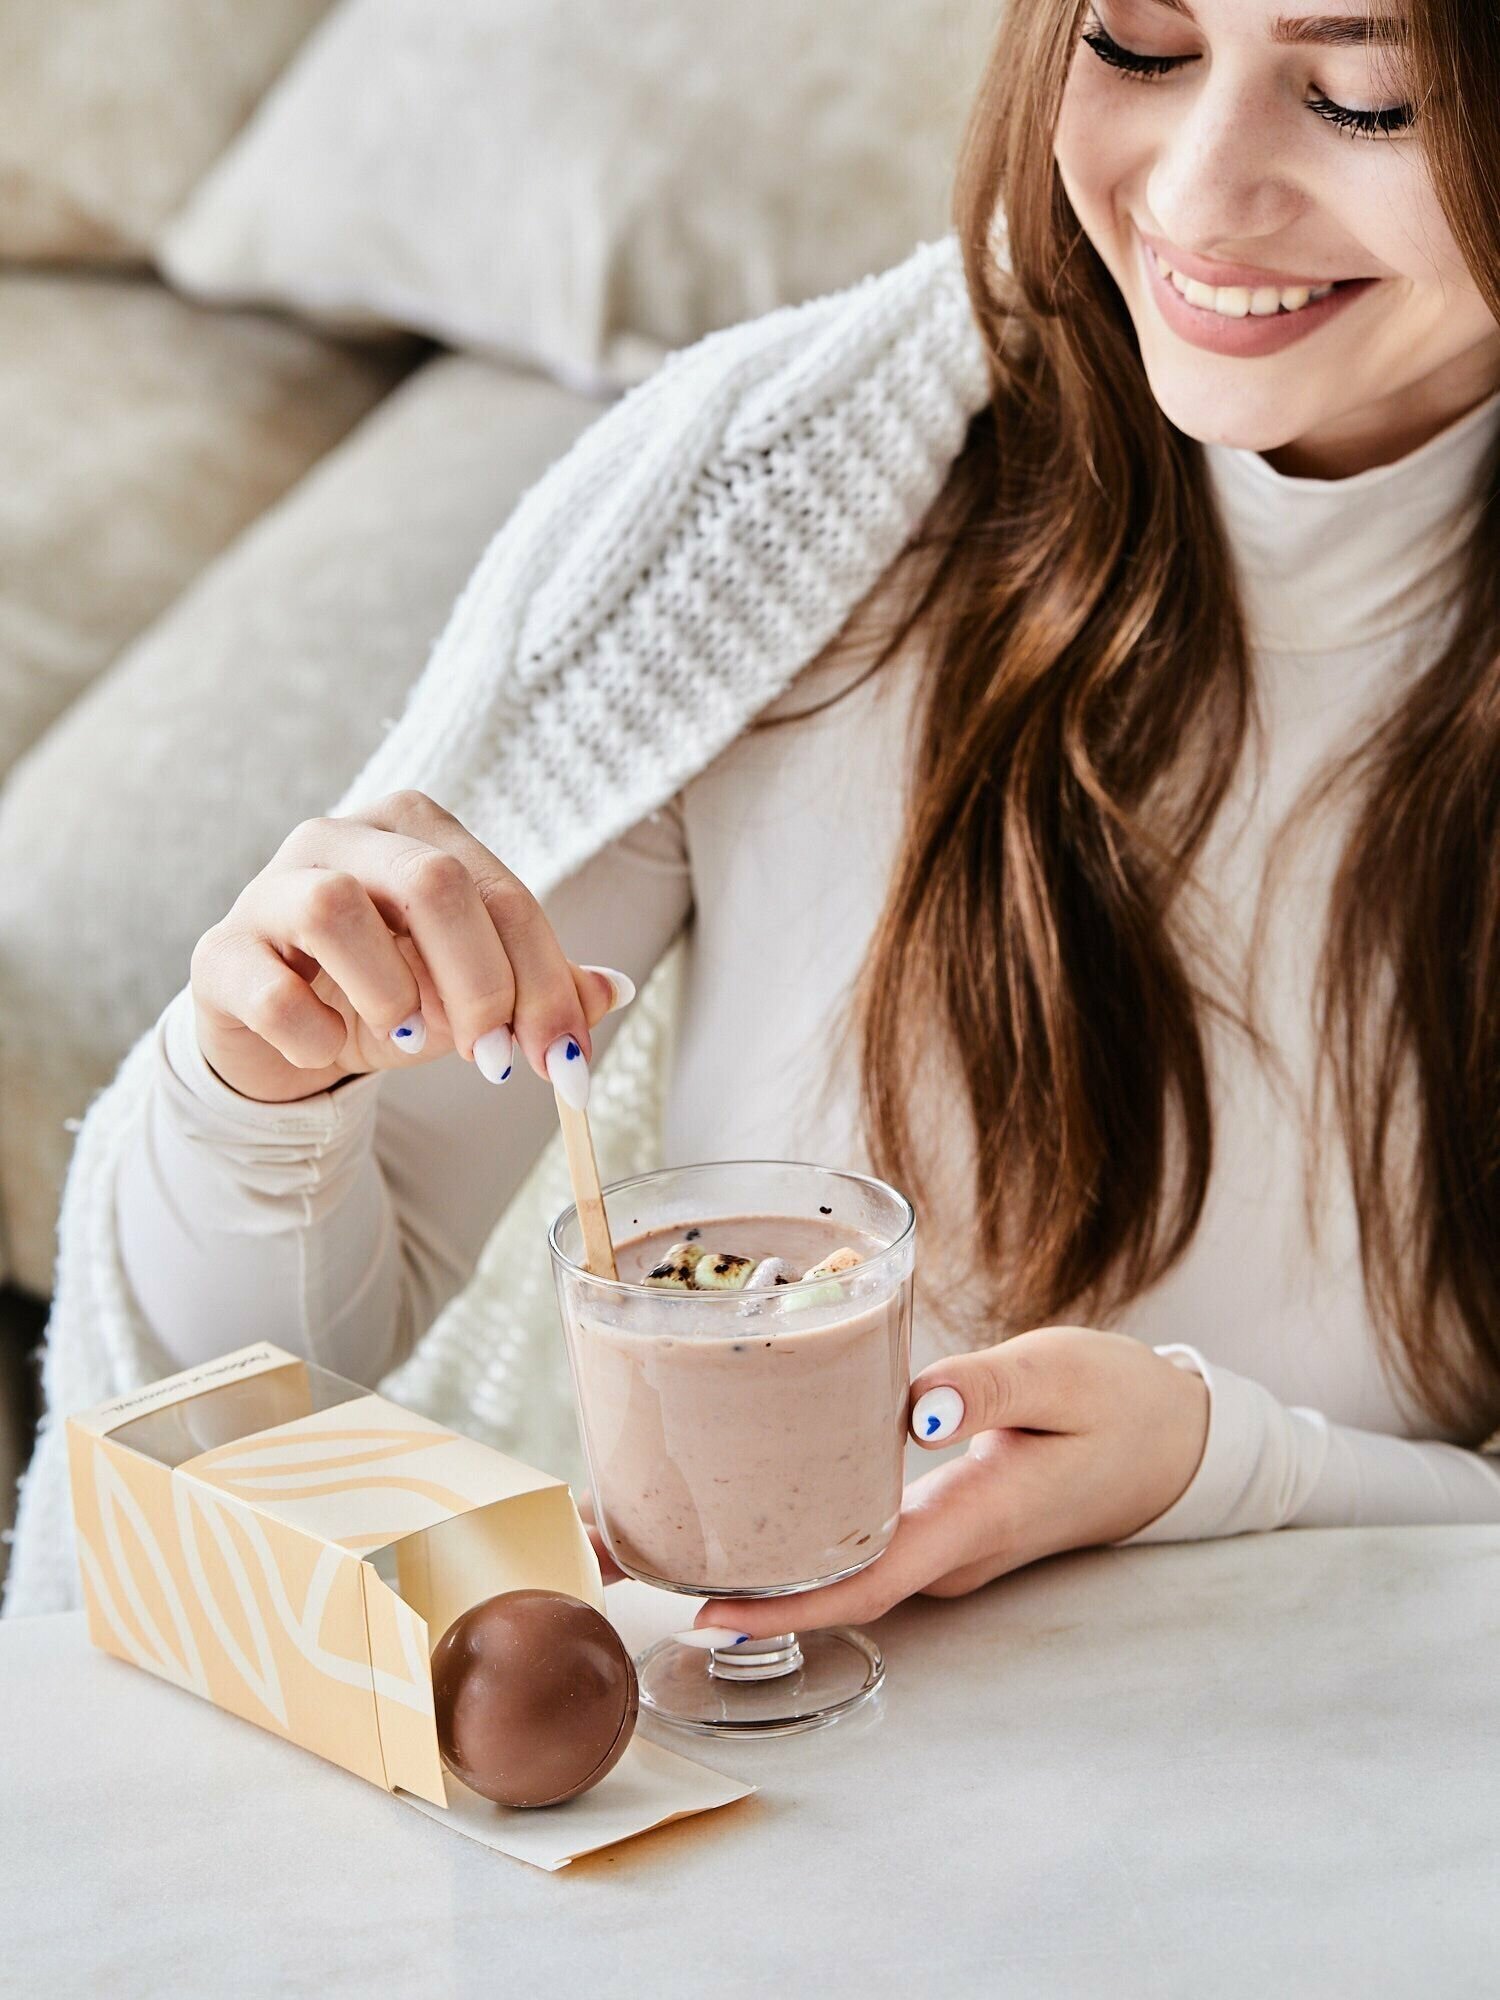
160;0;998;390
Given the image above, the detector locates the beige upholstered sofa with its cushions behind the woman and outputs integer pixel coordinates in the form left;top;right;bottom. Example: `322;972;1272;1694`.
0;0;994;1584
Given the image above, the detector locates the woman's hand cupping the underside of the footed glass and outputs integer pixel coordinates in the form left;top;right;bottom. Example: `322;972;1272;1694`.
694;1326;1208;1638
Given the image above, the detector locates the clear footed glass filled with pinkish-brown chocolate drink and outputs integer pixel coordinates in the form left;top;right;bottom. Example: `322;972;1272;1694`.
548;1160;916;1736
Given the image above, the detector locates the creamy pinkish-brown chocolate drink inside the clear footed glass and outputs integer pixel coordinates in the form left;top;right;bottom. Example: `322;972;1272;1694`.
564;1204;910;1596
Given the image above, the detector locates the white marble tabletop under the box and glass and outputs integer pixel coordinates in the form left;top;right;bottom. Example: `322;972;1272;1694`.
0;1528;1500;2000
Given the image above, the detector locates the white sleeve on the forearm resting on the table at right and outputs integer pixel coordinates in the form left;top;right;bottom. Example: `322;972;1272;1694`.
1118;1344;1500;1548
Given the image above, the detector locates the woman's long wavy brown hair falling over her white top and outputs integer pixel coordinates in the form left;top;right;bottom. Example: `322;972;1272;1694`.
768;0;1500;1440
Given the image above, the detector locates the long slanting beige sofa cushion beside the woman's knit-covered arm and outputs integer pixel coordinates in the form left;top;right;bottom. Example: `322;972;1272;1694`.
0;356;598;1296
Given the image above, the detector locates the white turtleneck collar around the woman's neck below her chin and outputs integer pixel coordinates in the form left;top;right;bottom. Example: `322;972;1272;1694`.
1202;378;1500;652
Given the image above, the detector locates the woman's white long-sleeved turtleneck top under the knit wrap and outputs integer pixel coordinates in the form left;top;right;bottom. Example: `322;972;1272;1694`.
118;394;1500;1540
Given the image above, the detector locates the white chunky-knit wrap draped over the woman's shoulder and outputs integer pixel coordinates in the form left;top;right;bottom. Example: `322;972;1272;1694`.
6;236;988;1612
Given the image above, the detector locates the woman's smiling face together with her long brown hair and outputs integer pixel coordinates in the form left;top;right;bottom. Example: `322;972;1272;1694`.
848;0;1500;1436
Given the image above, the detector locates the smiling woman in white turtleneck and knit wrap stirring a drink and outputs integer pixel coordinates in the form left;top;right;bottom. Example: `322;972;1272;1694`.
5;0;1500;1636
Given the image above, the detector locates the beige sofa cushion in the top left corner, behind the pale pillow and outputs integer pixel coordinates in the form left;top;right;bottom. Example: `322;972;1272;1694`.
0;0;330;264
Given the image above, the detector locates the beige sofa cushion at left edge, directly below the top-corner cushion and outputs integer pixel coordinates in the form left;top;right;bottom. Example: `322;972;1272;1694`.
0;270;410;780
